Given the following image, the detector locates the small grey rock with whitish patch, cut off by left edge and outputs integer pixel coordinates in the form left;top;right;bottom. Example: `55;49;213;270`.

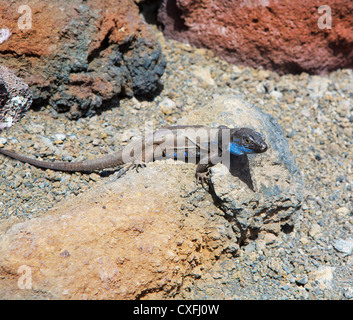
0;65;32;131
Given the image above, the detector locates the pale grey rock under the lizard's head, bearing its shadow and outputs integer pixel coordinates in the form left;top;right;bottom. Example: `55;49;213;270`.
179;95;304;239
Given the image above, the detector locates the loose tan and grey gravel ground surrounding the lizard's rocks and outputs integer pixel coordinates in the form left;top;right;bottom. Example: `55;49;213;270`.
0;26;353;299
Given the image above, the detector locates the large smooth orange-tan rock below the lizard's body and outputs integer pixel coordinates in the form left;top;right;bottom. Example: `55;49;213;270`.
0;165;236;299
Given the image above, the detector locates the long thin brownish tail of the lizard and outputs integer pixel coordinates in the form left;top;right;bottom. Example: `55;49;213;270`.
0;148;124;172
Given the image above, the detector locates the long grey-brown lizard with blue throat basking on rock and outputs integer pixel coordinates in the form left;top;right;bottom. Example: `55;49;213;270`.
0;125;268;184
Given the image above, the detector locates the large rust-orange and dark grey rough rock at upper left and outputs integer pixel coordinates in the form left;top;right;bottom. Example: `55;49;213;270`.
0;0;166;118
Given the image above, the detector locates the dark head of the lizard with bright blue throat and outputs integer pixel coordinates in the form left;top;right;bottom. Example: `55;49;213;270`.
229;128;267;156
